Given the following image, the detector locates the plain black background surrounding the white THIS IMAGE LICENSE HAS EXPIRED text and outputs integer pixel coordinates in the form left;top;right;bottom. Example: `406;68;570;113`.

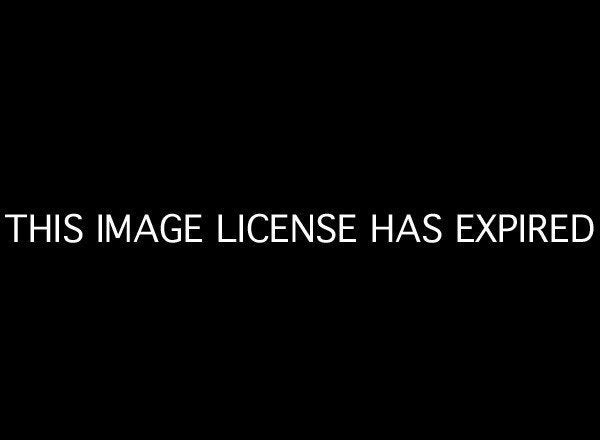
1;5;598;433
